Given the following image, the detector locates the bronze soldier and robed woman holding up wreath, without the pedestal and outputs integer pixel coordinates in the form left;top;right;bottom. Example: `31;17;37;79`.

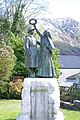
25;19;55;78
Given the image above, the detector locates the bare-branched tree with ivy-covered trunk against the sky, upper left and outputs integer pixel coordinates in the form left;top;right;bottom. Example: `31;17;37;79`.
0;0;47;35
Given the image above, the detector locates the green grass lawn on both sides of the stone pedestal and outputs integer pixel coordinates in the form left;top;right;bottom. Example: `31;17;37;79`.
0;100;80;120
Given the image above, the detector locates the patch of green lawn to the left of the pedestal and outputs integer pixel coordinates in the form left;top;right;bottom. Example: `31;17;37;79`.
0;100;21;120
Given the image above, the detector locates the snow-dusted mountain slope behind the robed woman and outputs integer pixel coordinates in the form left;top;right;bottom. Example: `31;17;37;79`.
41;18;80;55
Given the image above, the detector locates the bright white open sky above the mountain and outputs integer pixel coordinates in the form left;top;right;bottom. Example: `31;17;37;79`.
46;0;80;22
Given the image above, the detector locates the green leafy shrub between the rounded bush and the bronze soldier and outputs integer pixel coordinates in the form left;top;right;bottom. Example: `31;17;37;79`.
9;33;28;76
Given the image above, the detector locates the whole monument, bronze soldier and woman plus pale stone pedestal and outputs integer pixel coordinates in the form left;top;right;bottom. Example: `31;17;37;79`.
16;19;64;120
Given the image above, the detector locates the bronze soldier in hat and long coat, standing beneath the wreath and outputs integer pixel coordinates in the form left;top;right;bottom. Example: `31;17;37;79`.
25;25;38;77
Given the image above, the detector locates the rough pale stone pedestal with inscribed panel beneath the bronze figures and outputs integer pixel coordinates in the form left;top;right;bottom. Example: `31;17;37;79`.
16;78;64;120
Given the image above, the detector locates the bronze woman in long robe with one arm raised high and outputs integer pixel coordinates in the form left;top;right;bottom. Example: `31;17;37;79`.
34;26;55;77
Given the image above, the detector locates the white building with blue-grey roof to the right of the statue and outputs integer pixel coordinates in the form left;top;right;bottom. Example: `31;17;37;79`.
58;55;80;86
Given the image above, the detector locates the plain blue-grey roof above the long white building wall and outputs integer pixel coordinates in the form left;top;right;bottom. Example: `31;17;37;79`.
59;55;80;69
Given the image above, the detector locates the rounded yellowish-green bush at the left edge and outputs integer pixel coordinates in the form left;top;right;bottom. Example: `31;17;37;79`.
0;44;15;80
